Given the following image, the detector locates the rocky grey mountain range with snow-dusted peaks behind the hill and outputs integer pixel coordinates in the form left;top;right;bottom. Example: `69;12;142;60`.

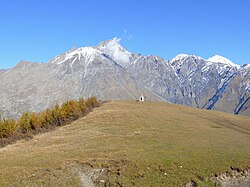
0;38;250;117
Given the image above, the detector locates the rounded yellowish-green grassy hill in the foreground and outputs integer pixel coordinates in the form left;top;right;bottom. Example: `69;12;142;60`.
0;101;250;186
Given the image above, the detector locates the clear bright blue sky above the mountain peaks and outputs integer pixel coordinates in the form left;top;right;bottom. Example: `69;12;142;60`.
0;0;250;68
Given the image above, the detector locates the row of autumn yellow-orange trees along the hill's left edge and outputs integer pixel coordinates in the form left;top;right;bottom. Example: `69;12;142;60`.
0;97;101;147
